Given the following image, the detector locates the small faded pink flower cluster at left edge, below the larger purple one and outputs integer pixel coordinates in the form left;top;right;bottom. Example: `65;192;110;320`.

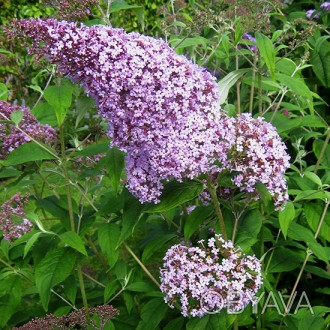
0;193;33;241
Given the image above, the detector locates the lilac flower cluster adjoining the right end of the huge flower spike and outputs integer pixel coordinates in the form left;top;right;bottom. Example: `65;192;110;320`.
226;114;290;209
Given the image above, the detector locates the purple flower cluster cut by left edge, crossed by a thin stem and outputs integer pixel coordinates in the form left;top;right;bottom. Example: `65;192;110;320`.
0;101;56;159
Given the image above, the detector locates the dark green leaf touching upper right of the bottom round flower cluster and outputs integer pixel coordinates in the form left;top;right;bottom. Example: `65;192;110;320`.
235;209;262;251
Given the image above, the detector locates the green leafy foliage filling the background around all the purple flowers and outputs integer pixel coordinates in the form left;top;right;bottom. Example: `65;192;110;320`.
0;0;330;330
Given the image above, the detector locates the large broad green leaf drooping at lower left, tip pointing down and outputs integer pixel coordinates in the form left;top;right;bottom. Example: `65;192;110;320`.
35;248;76;311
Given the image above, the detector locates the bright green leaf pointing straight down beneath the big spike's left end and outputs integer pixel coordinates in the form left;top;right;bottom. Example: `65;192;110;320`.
44;85;73;126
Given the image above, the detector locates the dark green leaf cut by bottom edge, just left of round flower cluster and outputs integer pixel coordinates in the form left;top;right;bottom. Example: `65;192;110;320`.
137;298;167;330
